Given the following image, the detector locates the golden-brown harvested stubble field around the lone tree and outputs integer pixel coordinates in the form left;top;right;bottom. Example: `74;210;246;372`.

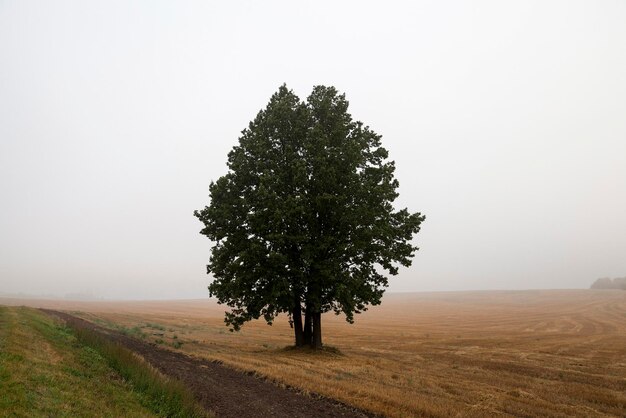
0;290;626;417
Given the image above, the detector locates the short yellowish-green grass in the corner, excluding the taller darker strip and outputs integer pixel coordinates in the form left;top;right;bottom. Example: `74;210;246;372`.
0;306;155;417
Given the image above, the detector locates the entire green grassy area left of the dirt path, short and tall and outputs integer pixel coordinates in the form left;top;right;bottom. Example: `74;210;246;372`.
0;306;209;418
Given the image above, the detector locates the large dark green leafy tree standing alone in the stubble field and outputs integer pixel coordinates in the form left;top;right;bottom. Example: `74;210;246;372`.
194;85;424;348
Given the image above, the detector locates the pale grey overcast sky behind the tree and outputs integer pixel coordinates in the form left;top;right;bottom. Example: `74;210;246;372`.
0;0;626;299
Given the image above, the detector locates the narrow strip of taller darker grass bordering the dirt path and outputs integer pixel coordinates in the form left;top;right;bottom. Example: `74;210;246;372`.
69;325;212;418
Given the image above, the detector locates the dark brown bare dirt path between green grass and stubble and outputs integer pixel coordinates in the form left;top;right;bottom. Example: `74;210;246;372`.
42;309;373;418
